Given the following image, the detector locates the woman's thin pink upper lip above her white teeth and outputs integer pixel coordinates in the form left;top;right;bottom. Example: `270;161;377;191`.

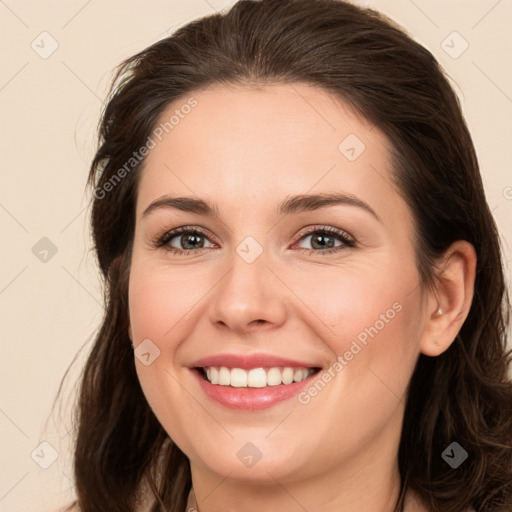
189;353;320;369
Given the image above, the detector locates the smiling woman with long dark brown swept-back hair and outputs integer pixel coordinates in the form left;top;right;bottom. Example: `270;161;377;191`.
62;0;512;512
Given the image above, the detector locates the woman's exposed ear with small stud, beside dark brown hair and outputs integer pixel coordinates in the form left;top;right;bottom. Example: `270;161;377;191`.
420;240;476;357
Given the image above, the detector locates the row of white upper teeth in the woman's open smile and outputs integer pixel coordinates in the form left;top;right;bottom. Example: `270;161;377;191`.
204;366;314;388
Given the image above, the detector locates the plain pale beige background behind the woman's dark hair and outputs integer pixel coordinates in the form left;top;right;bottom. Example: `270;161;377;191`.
0;0;512;512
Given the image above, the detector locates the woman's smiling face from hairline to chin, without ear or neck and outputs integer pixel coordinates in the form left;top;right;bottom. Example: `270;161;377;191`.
129;84;425;483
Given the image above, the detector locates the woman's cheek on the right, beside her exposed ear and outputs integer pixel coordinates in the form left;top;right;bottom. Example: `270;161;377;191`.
292;265;421;440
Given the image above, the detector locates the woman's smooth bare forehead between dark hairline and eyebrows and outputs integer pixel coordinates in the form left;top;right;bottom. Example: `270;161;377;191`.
137;84;399;220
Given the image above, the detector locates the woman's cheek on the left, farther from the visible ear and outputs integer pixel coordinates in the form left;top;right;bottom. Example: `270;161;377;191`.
129;257;207;453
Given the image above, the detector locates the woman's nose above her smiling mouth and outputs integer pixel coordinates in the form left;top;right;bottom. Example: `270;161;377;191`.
210;247;289;336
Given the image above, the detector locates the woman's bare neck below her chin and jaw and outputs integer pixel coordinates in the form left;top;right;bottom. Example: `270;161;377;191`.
187;409;427;512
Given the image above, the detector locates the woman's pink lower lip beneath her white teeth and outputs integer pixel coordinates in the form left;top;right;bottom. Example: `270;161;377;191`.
192;369;318;409
